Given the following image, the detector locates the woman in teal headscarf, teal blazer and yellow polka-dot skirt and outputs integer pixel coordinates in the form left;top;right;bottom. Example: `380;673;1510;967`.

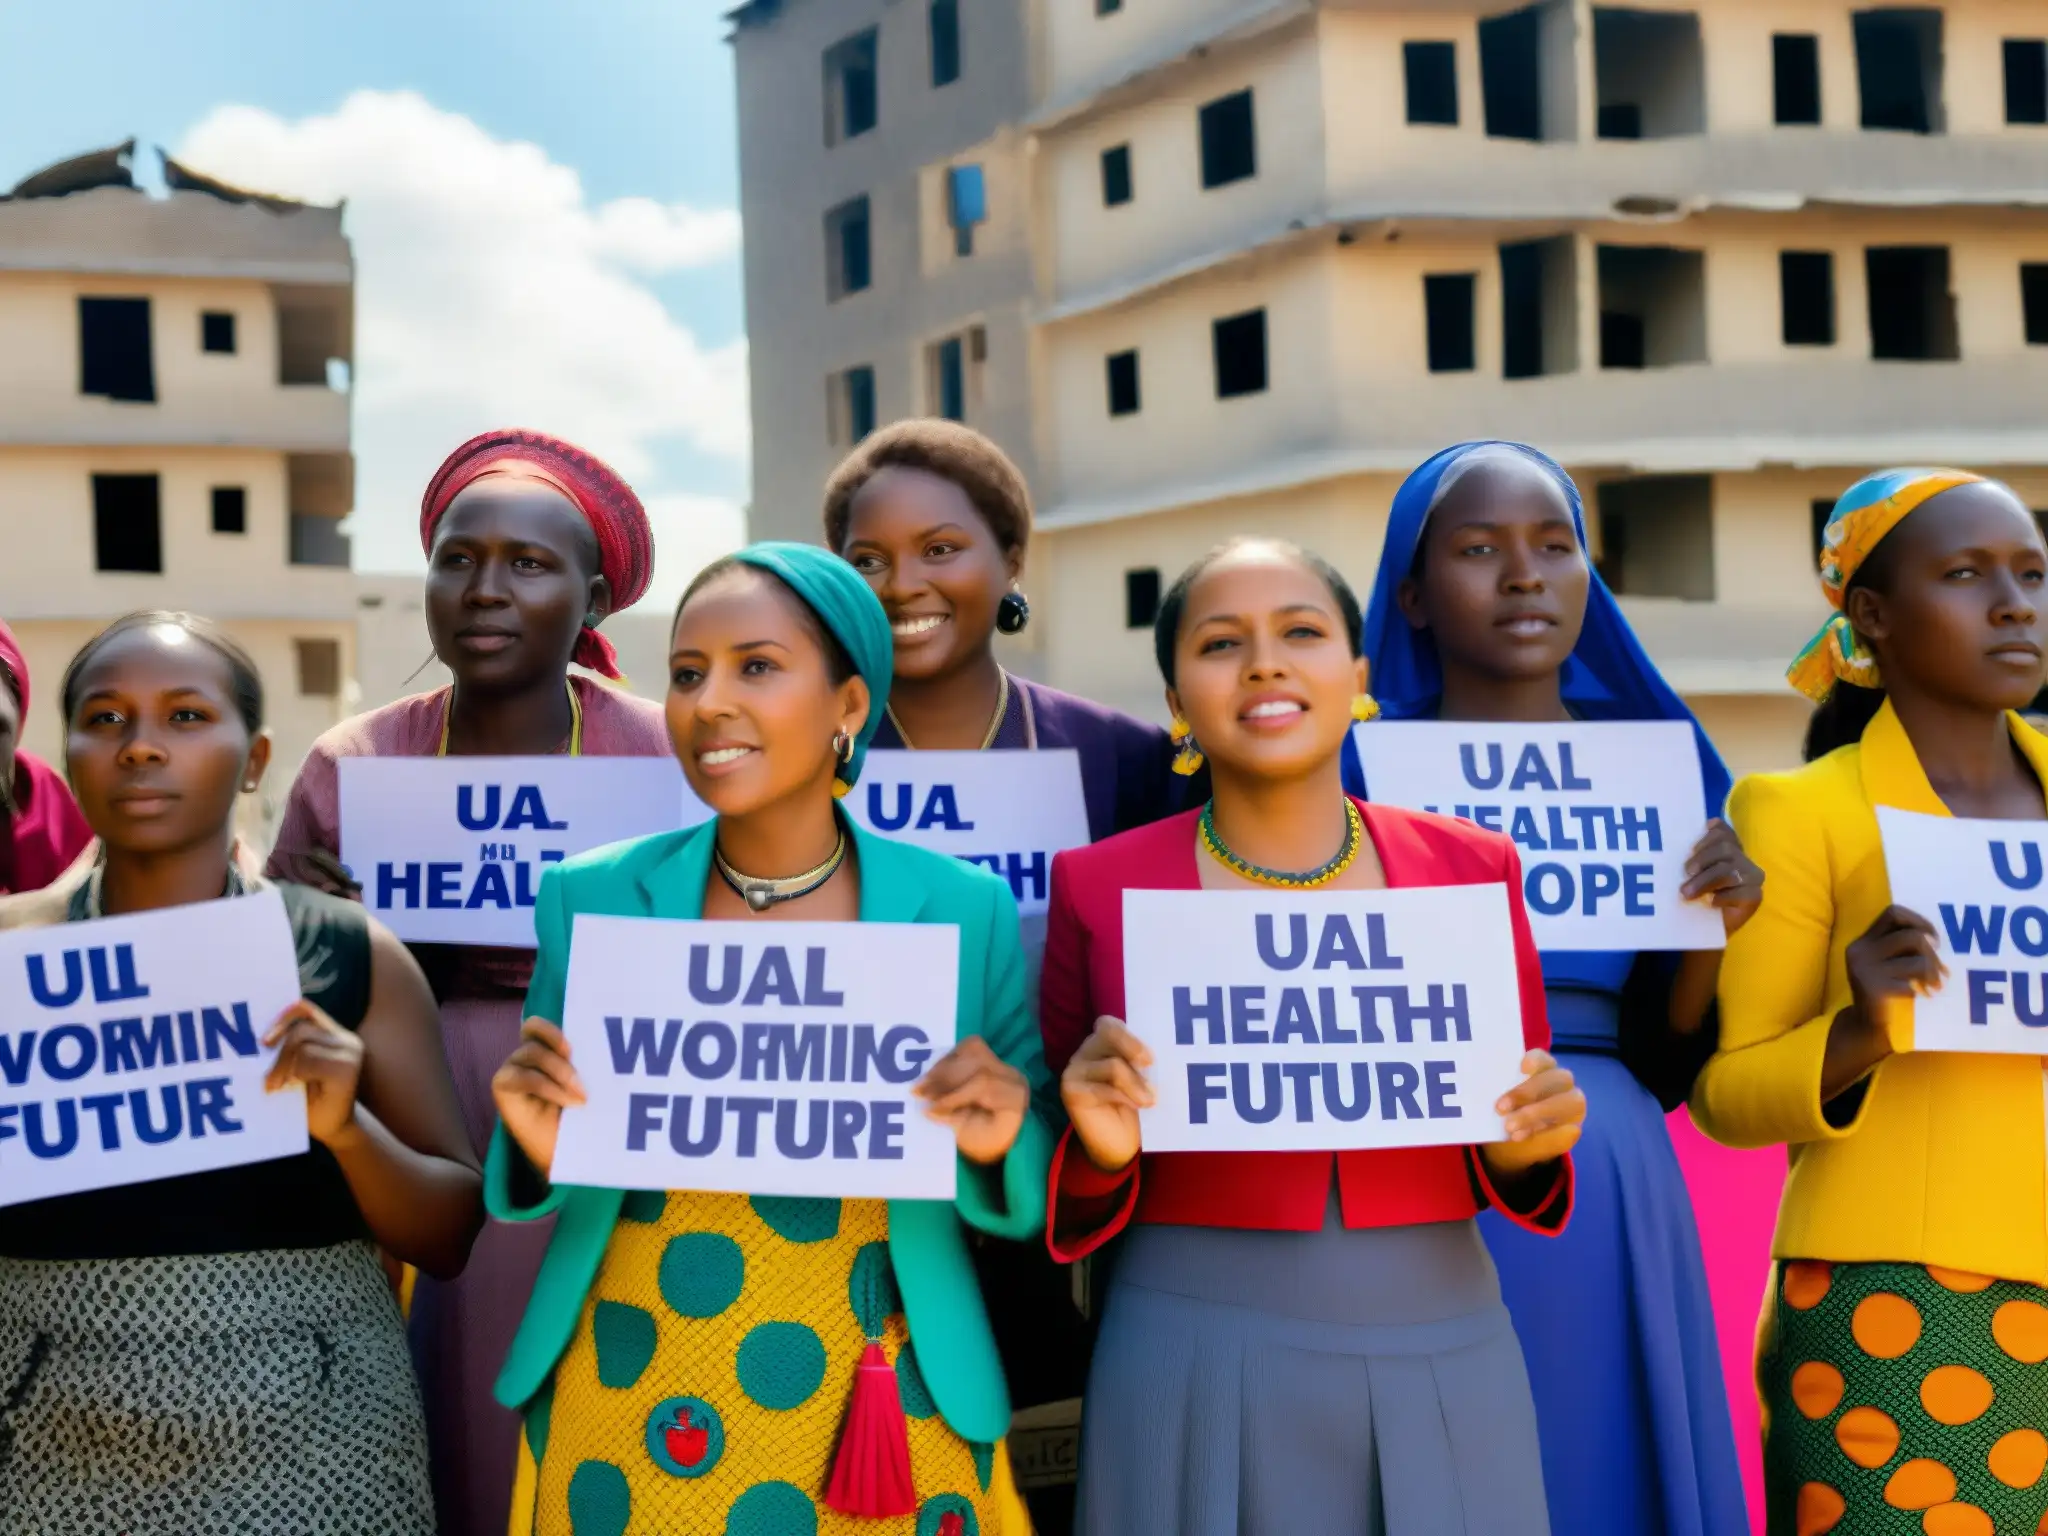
485;545;1051;1536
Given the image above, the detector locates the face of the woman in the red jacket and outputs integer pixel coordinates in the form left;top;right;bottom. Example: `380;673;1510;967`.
1167;545;1366;780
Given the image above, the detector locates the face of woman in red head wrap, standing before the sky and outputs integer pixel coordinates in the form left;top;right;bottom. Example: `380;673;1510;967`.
426;475;610;692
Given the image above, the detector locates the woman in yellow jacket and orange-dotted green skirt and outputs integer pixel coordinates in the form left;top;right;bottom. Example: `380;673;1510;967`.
1694;469;2048;1536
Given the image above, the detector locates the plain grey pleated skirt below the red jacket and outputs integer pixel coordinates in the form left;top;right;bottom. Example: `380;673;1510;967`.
1075;1221;1550;1536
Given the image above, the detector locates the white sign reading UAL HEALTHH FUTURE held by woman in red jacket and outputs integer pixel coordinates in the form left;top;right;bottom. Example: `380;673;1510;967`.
1124;885;1524;1151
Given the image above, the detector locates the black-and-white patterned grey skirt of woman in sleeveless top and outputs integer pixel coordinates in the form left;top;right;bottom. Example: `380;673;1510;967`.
0;1243;434;1536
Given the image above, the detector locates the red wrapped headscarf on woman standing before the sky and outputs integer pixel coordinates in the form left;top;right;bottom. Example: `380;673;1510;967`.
423;428;653;675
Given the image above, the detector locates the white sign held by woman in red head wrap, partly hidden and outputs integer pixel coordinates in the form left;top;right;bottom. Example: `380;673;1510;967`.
340;758;711;948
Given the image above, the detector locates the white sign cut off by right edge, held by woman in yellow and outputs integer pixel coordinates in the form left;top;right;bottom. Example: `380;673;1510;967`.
1878;805;2048;1057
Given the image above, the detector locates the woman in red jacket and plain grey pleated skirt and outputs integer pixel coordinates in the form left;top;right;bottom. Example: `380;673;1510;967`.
1040;541;1585;1536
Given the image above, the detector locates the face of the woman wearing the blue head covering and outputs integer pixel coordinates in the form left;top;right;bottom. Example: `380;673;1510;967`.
1401;455;1591;682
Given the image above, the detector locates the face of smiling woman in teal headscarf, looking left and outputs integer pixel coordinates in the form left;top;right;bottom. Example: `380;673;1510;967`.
668;565;868;817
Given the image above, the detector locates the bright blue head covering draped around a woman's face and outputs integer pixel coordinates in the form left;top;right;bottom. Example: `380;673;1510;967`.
1364;440;1731;815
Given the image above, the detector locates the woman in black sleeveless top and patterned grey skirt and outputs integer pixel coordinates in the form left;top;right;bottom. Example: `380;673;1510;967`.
0;612;483;1536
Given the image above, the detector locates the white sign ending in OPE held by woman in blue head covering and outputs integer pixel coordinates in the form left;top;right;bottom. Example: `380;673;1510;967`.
1352;721;1726;950
